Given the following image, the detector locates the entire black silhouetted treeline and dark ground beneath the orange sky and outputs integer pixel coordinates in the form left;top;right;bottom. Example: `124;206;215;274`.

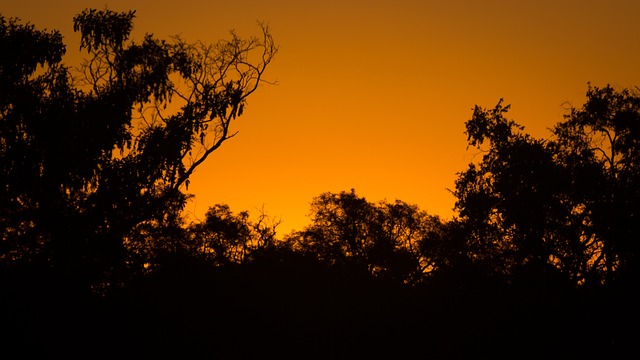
0;10;640;359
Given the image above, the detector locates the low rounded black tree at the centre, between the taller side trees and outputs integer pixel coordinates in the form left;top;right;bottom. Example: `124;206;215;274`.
287;190;441;283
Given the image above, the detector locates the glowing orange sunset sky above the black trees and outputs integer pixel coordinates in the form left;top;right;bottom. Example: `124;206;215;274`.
0;0;640;234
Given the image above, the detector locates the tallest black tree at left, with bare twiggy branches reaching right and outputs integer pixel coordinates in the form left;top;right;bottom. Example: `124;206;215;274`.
0;9;277;283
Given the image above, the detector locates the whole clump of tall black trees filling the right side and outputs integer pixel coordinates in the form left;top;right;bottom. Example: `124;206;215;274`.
454;86;640;285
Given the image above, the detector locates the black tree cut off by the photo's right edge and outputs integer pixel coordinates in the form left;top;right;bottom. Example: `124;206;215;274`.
553;85;640;281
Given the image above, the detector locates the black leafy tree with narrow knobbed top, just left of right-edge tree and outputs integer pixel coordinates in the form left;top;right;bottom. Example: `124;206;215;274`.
455;101;565;286
